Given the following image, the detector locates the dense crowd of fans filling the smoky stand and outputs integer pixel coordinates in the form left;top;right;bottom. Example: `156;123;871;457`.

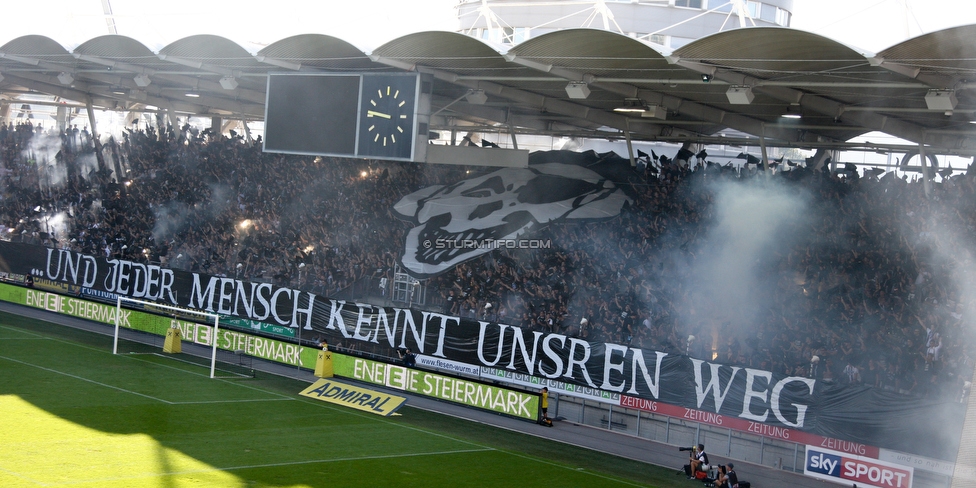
0;119;976;398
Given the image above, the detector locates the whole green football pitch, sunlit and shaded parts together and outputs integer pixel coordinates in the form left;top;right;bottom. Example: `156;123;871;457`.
0;313;688;488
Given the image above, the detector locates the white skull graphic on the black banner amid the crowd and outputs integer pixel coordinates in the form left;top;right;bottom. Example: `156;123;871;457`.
394;163;631;277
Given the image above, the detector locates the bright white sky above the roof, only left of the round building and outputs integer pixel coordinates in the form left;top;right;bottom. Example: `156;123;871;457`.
0;0;457;53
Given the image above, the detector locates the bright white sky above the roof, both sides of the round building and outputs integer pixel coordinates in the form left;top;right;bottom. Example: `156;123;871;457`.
0;0;976;52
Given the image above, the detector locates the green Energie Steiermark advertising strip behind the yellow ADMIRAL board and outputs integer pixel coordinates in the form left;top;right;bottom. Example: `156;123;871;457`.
332;354;539;421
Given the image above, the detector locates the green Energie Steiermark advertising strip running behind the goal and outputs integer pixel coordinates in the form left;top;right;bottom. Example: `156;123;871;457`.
0;283;319;369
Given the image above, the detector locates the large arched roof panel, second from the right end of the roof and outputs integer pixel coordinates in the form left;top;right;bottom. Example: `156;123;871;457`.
674;27;941;144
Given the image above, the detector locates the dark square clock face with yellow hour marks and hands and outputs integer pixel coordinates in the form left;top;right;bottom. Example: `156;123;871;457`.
358;75;417;159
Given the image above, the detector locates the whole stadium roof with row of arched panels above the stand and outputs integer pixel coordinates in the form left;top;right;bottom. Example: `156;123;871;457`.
0;25;976;155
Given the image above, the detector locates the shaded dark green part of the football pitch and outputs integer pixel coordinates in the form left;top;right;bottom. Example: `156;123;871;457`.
0;313;698;488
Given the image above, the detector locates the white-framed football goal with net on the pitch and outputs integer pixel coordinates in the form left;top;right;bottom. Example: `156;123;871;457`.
112;296;254;378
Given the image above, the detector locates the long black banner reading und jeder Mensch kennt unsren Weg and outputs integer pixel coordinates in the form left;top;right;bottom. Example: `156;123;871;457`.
0;242;964;459
